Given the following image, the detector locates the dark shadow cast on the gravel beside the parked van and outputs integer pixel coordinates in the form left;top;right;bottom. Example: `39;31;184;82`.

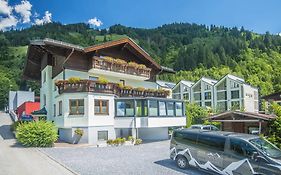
154;159;207;175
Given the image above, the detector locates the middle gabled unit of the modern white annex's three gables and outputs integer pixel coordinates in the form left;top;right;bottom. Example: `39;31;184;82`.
191;77;217;108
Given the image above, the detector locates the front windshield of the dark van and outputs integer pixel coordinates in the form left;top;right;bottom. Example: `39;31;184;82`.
249;138;281;158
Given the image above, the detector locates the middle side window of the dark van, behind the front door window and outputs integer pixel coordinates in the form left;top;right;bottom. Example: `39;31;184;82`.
197;135;225;151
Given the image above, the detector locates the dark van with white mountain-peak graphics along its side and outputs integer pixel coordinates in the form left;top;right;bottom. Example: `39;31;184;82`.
170;129;281;175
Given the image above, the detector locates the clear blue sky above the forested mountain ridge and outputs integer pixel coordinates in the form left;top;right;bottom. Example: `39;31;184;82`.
0;0;281;34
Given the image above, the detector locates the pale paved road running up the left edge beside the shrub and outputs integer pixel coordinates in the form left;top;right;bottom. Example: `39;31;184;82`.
0;112;73;175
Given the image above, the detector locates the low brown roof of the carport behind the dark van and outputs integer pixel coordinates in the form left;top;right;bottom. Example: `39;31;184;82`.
209;111;276;120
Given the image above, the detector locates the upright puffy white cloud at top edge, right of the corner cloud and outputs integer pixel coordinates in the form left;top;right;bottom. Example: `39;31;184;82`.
15;0;32;23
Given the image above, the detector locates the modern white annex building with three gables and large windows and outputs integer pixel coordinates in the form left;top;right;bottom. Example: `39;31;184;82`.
173;74;259;113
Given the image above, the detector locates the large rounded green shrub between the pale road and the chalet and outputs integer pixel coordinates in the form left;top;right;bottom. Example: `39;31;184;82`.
16;121;58;147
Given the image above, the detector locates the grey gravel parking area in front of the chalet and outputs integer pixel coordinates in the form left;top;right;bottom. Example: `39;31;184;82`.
40;141;206;175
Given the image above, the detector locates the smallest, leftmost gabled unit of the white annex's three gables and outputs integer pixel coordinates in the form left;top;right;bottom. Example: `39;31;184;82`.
172;80;194;102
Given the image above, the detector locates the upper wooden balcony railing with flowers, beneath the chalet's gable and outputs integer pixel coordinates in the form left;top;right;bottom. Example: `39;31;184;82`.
92;56;151;78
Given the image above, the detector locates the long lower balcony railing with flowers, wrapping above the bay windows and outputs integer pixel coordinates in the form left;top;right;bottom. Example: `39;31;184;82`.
56;80;169;98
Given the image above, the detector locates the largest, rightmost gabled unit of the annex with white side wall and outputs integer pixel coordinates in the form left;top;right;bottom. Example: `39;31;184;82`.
214;74;259;113
